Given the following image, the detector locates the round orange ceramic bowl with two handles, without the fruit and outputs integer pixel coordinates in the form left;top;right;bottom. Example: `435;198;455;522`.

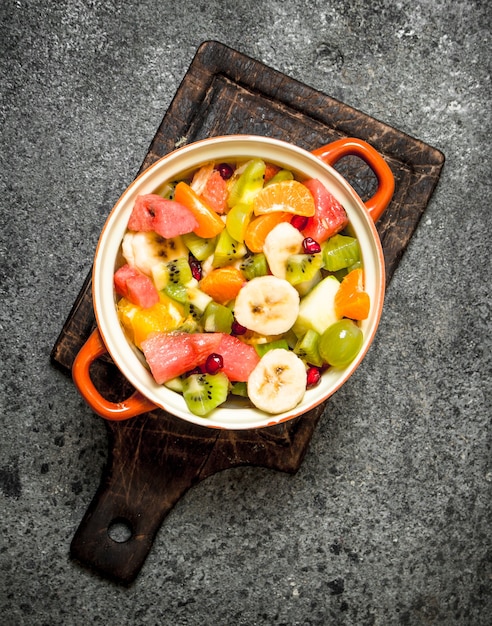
73;135;394;429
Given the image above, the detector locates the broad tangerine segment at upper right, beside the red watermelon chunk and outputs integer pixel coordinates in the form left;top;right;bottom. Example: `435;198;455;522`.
253;180;316;217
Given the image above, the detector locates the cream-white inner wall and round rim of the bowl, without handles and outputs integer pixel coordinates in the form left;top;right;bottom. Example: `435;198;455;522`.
93;135;384;429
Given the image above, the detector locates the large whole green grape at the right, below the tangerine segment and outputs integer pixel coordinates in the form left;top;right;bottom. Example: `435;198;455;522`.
318;319;364;367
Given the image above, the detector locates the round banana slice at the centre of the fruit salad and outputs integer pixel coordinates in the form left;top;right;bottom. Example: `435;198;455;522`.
234;276;300;335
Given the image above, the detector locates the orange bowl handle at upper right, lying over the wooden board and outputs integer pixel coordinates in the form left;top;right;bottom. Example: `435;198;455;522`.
312;137;395;222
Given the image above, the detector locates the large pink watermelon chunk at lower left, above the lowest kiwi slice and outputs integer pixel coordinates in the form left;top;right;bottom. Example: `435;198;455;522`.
142;332;221;385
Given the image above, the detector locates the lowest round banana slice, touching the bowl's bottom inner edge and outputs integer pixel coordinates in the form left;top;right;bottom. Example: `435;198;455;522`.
248;348;307;413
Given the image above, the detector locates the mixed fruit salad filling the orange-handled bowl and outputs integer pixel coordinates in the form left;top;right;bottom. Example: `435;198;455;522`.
114;158;370;417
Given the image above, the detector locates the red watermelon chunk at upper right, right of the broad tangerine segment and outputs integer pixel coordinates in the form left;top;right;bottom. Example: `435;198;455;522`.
302;178;348;243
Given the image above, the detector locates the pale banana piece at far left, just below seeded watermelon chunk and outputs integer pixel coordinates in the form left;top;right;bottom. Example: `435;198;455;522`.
121;231;188;276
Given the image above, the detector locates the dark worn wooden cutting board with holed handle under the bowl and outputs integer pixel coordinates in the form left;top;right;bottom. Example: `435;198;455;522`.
51;41;444;584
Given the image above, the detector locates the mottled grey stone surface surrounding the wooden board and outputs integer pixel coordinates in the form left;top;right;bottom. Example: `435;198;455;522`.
0;0;492;626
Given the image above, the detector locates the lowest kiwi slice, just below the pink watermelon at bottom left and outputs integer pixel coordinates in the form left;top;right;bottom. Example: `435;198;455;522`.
183;372;229;416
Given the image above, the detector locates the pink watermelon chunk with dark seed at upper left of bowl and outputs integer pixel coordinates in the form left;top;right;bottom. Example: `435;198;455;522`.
128;193;202;239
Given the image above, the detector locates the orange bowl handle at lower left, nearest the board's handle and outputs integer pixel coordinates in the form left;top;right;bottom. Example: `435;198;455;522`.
72;328;157;421
